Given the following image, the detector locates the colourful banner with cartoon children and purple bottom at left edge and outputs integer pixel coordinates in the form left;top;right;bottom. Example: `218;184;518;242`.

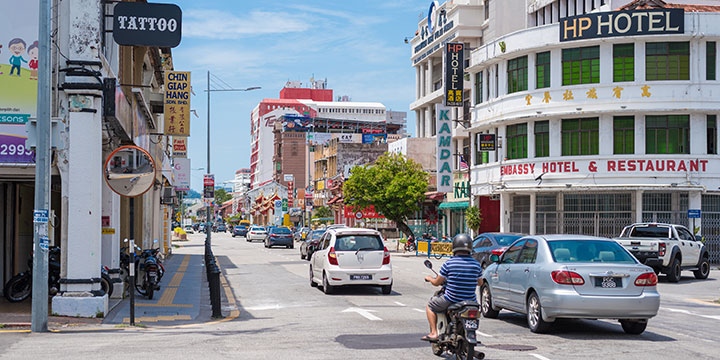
0;0;39;163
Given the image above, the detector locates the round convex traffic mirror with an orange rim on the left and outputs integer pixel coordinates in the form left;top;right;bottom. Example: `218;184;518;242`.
105;145;157;197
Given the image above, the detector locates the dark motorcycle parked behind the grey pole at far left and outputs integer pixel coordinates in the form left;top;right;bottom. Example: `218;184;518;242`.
3;246;60;302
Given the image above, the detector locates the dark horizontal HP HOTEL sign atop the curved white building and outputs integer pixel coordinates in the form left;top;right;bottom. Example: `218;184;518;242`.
560;9;685;41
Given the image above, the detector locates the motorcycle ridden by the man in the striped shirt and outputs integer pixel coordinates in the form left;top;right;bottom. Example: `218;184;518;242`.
425;260;485;360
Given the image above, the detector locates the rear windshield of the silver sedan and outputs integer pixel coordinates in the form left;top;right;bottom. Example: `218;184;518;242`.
548;240;637;264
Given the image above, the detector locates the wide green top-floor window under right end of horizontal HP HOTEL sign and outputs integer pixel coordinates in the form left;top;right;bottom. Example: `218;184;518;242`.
645;42;690;81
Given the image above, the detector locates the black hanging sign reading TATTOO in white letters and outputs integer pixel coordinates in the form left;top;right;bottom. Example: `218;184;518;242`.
113;2;182;48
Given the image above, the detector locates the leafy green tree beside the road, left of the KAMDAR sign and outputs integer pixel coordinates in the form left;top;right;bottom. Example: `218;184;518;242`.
343;153;428;236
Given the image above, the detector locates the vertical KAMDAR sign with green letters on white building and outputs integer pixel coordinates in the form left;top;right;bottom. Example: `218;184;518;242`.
435;104;453;193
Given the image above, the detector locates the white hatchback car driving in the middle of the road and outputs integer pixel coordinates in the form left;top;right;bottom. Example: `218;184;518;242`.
310;227;392;295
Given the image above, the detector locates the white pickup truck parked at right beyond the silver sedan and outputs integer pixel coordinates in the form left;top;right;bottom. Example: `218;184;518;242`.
615;223;710;282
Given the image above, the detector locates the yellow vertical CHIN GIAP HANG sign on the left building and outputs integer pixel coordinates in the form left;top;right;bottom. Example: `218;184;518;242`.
164;71;190;136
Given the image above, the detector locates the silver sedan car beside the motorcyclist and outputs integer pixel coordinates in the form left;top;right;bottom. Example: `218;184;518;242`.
480;235;660;334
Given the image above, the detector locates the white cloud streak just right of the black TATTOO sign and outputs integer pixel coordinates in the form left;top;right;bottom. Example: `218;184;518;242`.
183;10;310;40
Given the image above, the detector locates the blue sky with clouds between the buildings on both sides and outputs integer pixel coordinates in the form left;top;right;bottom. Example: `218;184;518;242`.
162;0;430;189
